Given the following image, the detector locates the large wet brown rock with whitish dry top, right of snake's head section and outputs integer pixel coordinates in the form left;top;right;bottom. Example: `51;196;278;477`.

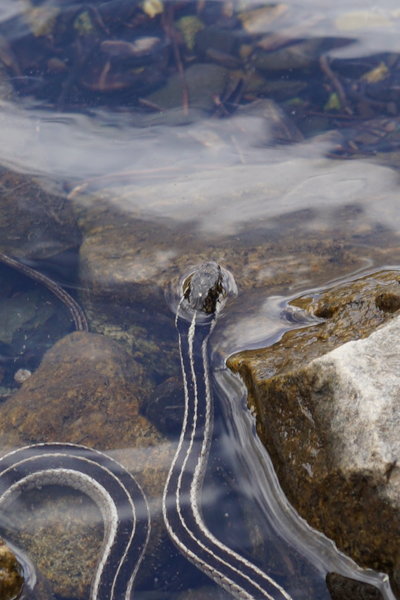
228;272;400;592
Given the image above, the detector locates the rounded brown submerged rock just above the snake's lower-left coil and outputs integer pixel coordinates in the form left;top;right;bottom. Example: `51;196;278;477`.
0;332;156;449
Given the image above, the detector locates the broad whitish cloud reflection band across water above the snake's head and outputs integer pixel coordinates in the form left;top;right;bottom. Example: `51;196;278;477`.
0;109;398;236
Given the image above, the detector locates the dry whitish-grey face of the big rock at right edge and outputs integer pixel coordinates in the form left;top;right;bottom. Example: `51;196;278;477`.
307;318;400;495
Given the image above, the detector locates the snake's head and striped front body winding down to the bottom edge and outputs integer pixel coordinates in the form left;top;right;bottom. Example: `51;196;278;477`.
163;263;290;600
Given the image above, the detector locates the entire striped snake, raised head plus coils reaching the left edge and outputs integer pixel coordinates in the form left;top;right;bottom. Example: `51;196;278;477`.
0;254;292;600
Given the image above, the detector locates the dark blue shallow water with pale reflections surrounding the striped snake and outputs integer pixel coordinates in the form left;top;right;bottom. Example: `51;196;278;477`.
0;0;400;600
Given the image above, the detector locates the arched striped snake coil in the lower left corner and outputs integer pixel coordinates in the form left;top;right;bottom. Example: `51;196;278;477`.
0;443;150;600
